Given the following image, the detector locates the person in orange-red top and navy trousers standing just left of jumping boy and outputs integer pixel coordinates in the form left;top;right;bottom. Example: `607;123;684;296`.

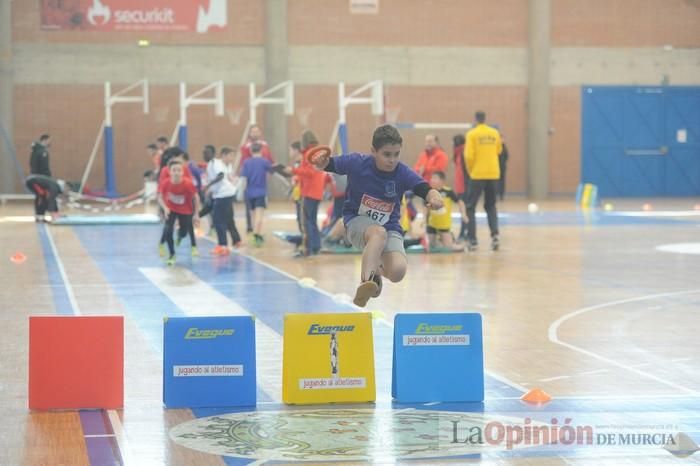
286;130;327;256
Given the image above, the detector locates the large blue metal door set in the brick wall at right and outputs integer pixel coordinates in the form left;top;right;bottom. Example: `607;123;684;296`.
581;86;700;197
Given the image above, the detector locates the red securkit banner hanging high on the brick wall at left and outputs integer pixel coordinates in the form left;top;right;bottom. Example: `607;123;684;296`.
41;0;228;34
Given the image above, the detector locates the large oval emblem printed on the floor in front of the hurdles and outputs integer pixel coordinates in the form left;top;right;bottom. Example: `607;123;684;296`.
170;409;545;461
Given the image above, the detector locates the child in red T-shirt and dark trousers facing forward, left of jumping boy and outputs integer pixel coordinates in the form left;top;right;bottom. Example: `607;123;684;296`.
158;159;200;265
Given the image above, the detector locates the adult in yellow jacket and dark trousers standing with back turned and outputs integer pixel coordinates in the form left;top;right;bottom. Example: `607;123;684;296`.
464;111;503;251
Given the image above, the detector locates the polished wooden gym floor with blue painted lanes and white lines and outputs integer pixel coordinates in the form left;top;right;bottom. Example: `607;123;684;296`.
0;199;700;465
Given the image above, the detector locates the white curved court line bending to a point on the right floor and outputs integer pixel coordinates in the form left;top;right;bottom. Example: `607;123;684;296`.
548;290;700;396
